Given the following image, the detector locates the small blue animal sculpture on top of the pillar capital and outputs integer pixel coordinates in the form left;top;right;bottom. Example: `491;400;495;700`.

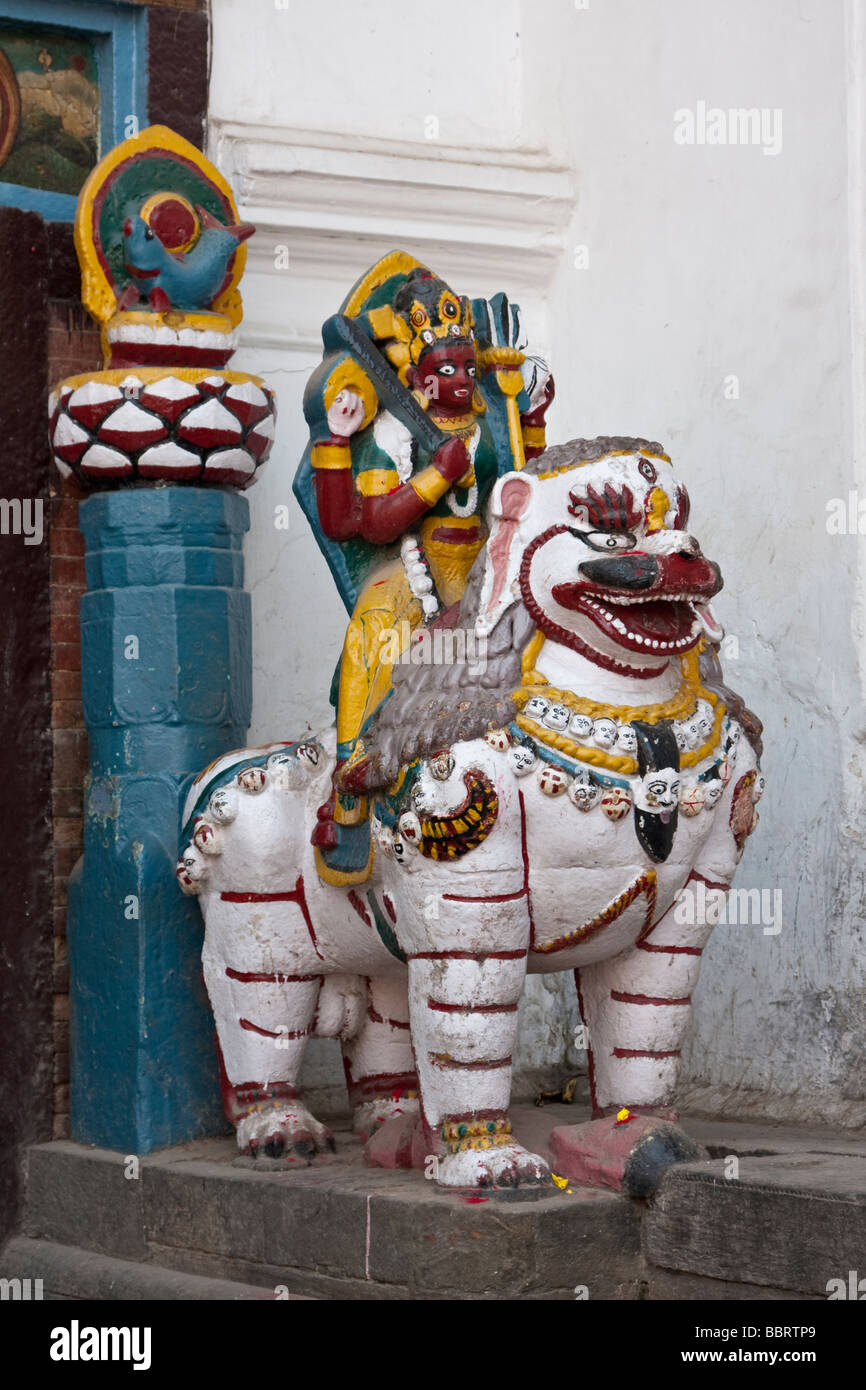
117;206;256;313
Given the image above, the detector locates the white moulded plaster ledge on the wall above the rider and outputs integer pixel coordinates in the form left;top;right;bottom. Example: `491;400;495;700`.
210;120;575;298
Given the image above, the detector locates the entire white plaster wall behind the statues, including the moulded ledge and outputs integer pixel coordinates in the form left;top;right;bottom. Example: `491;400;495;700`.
210;0;866;1123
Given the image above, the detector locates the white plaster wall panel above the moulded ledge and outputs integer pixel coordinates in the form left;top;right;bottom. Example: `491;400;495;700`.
210;0;527;149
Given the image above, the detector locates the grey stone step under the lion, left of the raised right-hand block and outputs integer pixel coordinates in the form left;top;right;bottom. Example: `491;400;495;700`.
26;1131;645;1300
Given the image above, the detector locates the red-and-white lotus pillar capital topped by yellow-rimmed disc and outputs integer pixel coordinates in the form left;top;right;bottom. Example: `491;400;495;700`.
49;125;275;488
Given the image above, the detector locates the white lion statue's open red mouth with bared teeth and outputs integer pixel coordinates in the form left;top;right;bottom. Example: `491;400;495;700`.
552;584;705;655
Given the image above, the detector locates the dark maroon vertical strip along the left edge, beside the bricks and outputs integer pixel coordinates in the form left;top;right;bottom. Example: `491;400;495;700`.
0;207;53;1241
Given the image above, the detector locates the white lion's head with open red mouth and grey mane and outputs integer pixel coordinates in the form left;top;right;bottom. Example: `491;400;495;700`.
364;435;741;785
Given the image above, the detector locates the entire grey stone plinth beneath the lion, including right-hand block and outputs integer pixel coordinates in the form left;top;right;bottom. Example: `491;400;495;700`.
8;1105;866;1302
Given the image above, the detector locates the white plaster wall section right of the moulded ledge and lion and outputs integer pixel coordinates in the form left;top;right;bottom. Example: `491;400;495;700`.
527;0;866;1123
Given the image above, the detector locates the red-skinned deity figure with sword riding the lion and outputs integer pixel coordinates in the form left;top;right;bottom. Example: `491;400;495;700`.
295;252;553;884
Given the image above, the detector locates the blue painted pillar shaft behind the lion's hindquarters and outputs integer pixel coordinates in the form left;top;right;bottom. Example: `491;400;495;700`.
68;487;252;1154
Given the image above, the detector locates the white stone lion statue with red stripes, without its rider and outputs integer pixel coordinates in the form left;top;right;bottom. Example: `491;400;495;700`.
178;438;763;1190
